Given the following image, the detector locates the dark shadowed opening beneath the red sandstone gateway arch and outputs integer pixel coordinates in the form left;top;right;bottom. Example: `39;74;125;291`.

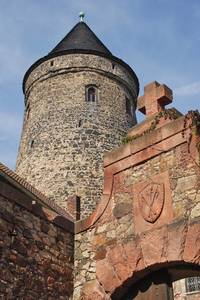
111;262;200;300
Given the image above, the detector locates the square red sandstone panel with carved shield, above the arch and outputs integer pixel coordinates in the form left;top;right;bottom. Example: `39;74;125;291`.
132;171;173;233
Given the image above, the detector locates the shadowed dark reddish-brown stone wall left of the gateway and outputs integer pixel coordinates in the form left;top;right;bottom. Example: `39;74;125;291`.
0;178;74;300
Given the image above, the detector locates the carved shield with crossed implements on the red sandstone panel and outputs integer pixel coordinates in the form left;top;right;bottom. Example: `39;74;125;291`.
139;183;165;223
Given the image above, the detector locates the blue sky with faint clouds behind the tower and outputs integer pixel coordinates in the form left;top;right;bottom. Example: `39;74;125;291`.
0;0;200;168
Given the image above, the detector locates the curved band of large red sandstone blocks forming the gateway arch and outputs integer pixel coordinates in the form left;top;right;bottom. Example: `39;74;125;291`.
96;218;200;299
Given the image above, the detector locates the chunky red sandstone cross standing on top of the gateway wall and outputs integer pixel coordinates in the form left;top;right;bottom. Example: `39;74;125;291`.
137;81;173;117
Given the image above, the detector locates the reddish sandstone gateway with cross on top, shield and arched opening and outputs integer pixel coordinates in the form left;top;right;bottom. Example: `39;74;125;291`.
74;82;200;300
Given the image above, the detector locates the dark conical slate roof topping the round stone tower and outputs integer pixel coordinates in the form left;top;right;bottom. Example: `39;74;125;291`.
49;22;112;55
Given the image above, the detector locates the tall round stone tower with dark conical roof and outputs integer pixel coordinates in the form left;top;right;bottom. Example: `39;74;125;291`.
16;18;139;217
